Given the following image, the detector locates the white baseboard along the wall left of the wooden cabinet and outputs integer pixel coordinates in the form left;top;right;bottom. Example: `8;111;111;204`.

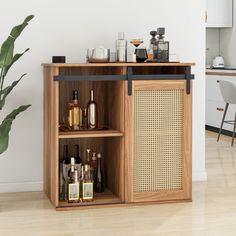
0;182;43;193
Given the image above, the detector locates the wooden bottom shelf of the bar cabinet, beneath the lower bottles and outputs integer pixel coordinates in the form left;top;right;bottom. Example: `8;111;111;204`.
57;189;122;209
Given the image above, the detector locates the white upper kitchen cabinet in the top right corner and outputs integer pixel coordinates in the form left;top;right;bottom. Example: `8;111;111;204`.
206;0;233;28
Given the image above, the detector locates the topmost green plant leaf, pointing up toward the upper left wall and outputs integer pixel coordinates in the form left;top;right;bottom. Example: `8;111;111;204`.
0;15;34;68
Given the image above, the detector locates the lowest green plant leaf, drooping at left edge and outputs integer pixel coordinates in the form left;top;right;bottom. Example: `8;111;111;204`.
0;105;31;154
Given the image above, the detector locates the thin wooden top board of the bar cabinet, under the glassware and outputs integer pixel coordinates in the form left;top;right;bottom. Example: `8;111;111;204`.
42;62;195;68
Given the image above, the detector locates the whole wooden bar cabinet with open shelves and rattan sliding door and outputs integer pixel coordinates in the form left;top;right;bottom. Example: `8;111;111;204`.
44;63;193;210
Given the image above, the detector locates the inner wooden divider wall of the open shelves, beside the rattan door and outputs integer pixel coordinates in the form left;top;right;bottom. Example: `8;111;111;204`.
104;79;125;202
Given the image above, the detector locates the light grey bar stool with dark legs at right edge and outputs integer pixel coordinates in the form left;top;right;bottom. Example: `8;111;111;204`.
217;80;236;146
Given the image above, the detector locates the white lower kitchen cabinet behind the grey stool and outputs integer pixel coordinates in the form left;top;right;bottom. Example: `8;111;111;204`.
206;73;236;131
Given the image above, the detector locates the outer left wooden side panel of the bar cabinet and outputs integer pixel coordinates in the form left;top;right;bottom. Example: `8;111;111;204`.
44;67;59;206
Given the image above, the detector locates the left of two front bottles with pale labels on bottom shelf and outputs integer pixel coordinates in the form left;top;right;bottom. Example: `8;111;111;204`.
68;157;80;203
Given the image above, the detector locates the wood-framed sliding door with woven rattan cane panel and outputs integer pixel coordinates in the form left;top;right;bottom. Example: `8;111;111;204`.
125;81;191;202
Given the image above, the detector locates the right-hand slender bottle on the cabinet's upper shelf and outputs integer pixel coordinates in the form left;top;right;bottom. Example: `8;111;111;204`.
87;90;98;129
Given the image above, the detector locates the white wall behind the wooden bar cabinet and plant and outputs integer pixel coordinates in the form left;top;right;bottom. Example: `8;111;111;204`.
0;0;206;192
